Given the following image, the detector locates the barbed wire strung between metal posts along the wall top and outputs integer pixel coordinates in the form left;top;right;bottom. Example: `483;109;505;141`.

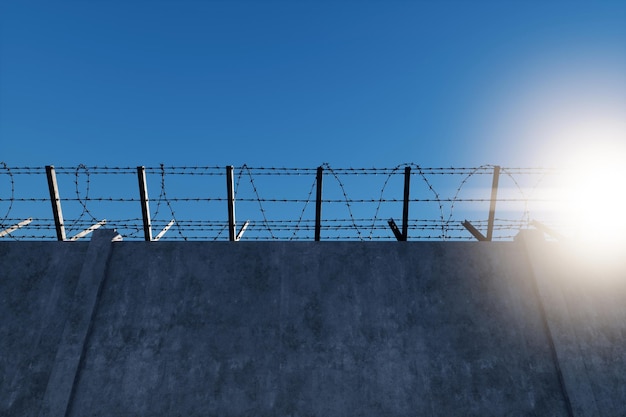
0;162;561;240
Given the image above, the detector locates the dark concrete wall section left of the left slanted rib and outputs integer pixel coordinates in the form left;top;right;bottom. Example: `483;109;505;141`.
0;242;87;416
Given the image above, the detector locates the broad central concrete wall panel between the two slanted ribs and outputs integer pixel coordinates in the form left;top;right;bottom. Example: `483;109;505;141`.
70;242;565;416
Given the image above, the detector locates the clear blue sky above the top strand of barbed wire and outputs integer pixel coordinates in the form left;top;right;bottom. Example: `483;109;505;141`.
0;0;626;167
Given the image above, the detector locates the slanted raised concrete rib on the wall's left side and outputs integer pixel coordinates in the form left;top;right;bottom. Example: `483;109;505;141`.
39;229;120;417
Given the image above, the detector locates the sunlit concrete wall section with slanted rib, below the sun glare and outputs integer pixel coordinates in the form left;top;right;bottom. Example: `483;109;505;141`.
521;231;626;416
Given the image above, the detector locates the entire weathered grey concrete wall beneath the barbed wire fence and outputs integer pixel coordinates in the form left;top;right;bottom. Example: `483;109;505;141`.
0;231;626;416
